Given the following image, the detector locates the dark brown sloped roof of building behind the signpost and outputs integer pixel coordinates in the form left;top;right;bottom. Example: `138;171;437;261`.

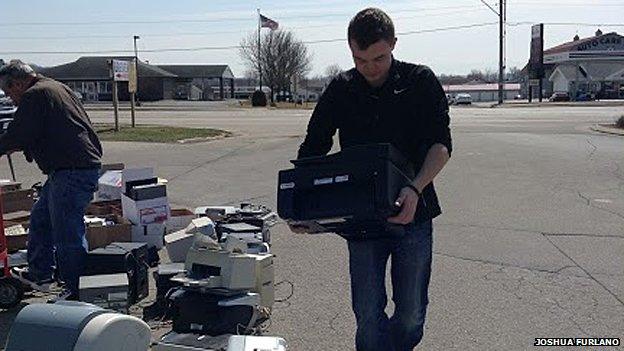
38;56;176;80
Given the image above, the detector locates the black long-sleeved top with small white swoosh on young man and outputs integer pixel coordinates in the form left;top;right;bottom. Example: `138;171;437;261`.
298;60;452;222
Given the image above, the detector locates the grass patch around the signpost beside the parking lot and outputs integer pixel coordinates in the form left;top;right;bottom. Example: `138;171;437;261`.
94;123;231;143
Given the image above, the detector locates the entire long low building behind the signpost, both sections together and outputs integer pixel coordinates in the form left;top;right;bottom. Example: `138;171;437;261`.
37;56;234;101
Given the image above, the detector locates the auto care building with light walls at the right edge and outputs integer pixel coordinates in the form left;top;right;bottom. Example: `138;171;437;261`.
527;30;624;99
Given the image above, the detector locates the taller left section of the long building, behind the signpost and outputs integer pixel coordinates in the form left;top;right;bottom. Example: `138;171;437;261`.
38;56;177;101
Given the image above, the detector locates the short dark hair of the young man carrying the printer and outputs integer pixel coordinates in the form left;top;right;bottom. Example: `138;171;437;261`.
347;7;394;50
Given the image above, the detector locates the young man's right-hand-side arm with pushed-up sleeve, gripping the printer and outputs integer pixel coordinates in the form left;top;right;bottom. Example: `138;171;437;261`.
388;68;453;224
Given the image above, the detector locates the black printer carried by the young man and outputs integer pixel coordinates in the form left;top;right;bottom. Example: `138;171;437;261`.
277;144;414;237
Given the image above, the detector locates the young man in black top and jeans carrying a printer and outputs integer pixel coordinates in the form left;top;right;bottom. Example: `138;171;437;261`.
291;8;451;351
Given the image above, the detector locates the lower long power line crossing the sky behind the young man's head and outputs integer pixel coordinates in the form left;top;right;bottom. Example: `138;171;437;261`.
0;22;498;55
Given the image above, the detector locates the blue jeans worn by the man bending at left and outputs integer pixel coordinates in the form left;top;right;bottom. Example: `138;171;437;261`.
28;169;99;294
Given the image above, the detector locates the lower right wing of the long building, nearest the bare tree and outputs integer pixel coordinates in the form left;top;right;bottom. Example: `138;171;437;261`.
158;65;234;100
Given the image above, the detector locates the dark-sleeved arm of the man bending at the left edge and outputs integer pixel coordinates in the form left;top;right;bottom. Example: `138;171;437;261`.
0;93;47;155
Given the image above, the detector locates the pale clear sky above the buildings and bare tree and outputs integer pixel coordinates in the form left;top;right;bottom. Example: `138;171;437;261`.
0;0;624;77
